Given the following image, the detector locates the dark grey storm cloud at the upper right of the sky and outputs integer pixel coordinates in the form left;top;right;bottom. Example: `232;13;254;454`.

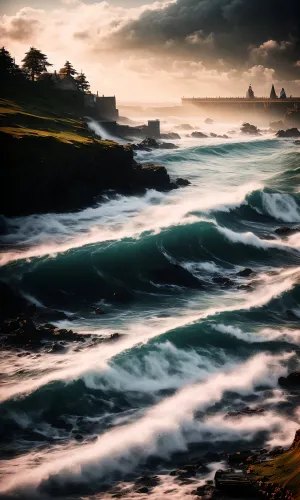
119;0;300;74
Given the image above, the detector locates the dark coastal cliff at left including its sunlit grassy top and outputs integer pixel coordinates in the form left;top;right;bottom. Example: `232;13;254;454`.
0;96;177;216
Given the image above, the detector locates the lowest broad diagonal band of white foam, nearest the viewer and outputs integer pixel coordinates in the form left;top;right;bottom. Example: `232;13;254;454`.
0;354;299;492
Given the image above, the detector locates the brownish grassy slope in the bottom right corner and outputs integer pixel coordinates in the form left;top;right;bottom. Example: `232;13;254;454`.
250;431;300;500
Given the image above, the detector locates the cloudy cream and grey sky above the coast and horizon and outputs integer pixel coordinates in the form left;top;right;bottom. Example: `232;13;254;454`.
0;0;300;103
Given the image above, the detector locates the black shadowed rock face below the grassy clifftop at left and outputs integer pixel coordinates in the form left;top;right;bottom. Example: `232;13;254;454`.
0;133;184;216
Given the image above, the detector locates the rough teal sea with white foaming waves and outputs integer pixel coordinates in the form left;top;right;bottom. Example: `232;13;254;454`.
0;116;300;500
